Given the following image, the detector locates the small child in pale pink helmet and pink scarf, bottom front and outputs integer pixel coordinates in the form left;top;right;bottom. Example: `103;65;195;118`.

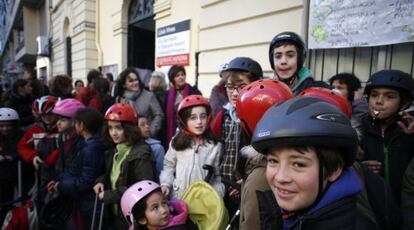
121;180;194;230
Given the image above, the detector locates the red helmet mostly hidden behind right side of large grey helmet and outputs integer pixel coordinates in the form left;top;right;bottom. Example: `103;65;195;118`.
298;87;352;118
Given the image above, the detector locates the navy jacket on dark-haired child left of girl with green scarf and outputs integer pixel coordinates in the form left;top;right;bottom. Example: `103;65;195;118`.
58;136;105;212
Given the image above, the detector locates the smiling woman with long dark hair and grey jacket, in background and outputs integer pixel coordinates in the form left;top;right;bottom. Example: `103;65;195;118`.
115;67;164;137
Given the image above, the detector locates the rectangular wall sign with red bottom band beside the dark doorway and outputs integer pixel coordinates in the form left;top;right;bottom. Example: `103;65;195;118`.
156;20;190;67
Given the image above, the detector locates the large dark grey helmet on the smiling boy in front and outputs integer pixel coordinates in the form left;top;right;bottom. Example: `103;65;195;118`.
252;97;358;167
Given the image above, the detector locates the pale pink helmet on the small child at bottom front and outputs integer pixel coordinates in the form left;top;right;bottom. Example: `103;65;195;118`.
121;180;160;227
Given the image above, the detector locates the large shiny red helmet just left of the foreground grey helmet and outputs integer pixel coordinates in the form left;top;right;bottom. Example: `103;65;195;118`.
236;79;293;137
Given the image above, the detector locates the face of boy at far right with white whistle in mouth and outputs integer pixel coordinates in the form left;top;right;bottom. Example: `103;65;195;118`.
368;87;401;120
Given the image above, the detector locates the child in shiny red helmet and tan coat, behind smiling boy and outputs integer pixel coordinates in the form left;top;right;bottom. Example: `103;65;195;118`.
236;79;293;230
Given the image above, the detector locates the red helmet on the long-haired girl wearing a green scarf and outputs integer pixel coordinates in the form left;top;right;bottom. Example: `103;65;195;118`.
104;103;138;124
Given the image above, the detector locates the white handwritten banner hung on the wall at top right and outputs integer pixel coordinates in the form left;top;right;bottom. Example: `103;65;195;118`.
308;0;414;49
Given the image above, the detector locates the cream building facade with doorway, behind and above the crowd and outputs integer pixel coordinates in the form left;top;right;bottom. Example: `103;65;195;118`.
0;0;414;97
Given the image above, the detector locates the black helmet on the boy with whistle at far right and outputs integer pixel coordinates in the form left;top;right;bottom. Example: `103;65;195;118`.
364;70;414;99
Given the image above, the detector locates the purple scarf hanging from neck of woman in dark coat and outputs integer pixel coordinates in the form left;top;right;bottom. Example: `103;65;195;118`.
165;84;190;144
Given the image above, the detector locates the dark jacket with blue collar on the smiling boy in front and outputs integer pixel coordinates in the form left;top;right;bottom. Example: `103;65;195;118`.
257;170;377;230
